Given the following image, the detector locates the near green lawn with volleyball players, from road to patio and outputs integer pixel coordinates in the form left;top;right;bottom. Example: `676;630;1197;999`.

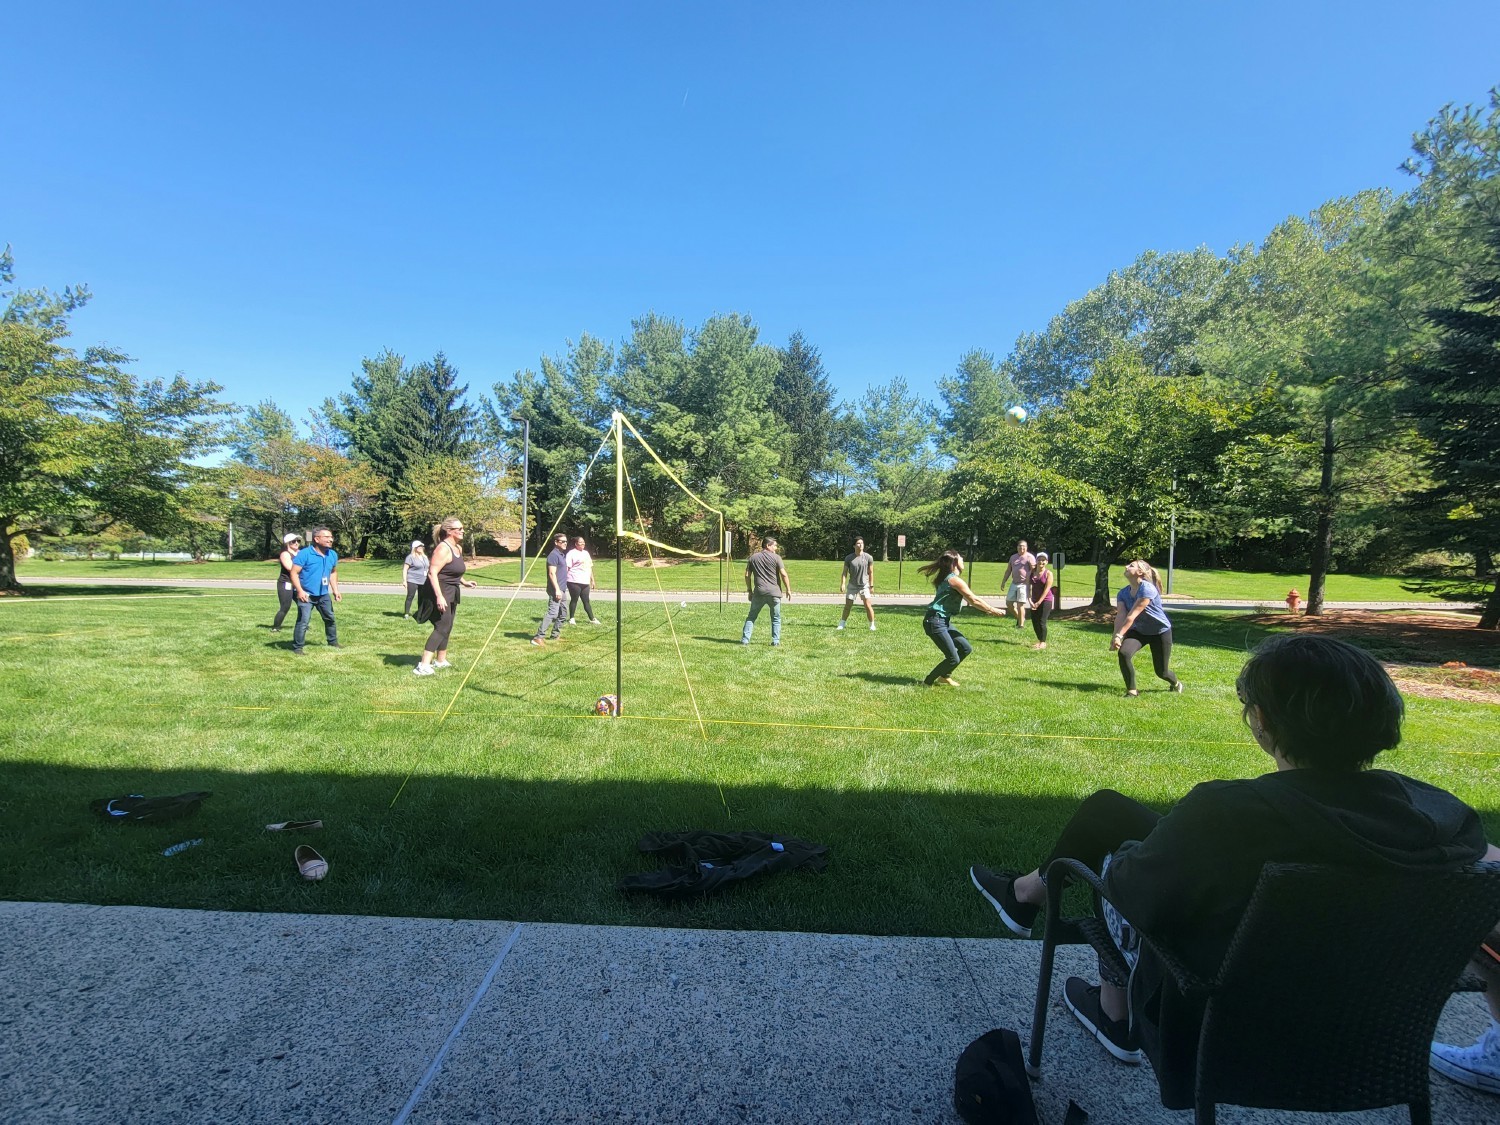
0;591;1500;935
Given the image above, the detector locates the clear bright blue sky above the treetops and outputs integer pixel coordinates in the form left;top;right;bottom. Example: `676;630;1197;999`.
11;0;1500;426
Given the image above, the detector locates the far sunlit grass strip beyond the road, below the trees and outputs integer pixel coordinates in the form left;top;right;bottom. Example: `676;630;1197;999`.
18;558;1439;605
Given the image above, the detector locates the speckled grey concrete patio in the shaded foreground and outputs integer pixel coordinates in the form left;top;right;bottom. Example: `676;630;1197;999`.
0;902;1500;1125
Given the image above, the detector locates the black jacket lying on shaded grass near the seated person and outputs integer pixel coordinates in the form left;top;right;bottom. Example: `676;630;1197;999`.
615;831;828;899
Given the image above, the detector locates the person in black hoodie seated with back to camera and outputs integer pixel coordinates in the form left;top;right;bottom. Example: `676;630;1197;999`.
969;636;1500;1080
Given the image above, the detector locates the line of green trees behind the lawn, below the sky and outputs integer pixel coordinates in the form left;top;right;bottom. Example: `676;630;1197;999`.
0;87;1500;627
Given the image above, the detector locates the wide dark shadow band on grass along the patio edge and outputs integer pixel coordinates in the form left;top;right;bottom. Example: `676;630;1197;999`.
0;762;1158;936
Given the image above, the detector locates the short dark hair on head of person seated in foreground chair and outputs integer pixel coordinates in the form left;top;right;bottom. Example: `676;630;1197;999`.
1236;636;1406;770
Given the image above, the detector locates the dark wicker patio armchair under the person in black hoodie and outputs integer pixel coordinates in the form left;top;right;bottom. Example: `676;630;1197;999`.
1028;860;1500;1125
